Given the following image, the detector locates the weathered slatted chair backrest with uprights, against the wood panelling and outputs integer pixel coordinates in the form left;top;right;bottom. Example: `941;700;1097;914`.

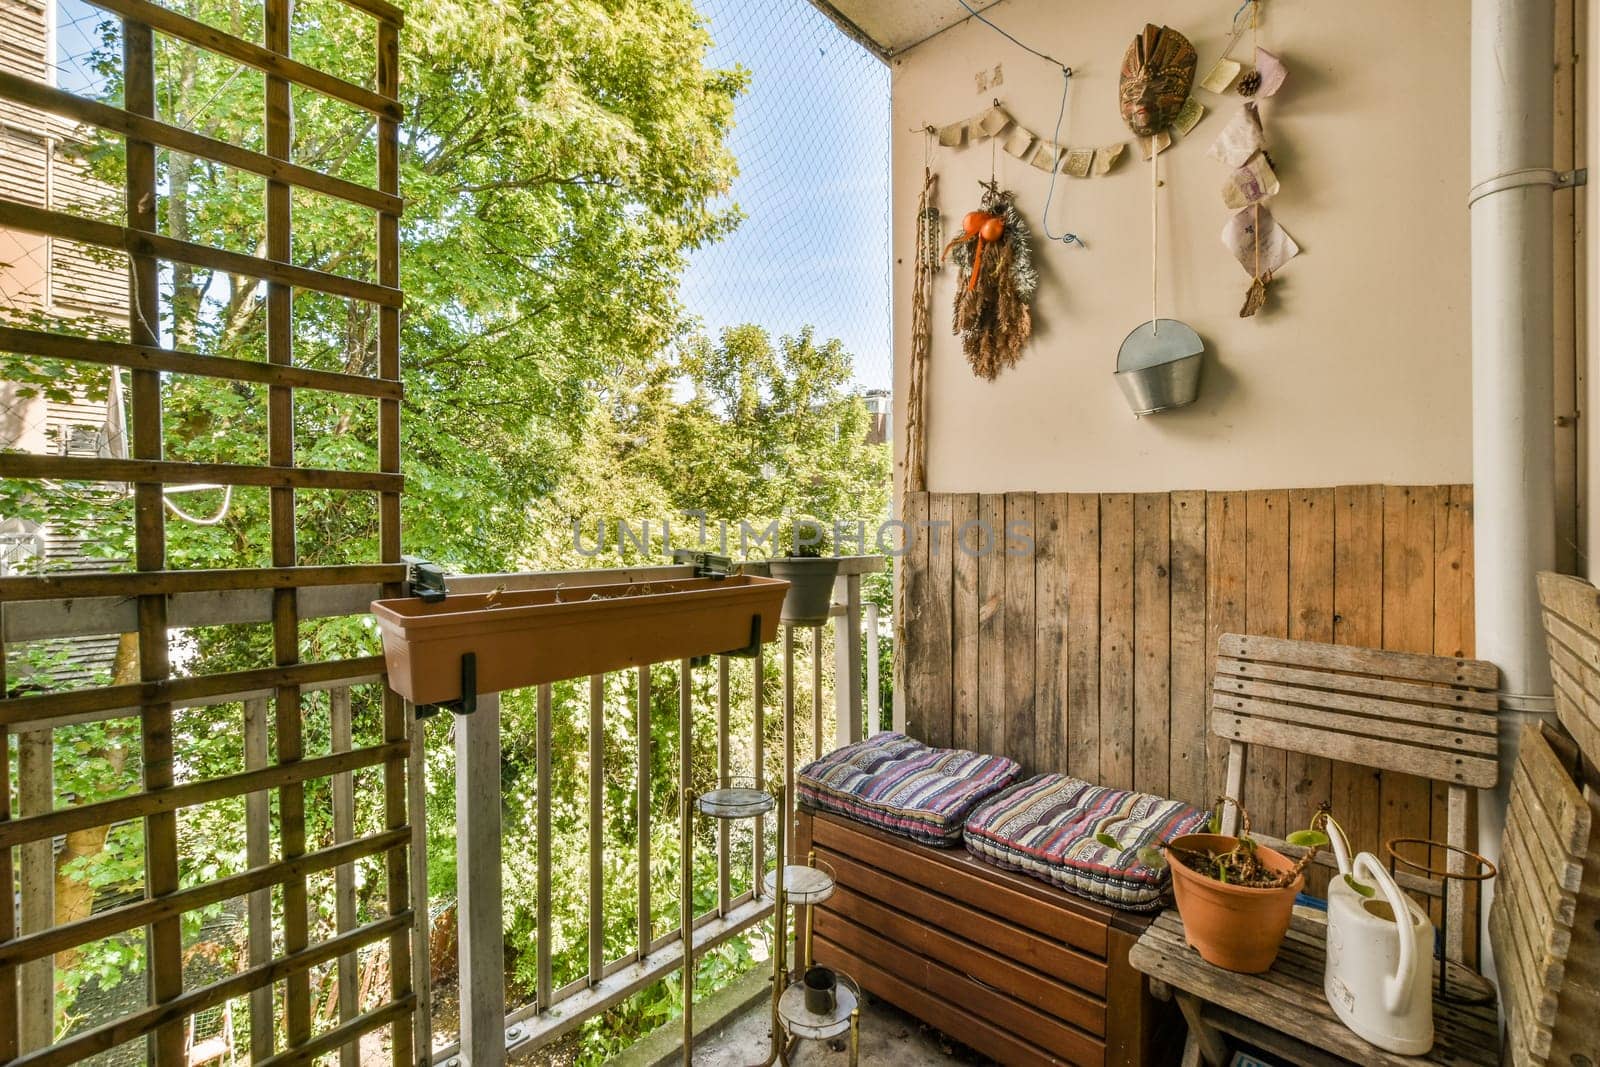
1211;633;1499;961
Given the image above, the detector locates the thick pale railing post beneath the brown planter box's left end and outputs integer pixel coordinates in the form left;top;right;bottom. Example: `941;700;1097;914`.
454;693;505;1067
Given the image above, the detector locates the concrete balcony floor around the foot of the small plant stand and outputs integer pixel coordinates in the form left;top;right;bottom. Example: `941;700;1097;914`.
694;997;989;1067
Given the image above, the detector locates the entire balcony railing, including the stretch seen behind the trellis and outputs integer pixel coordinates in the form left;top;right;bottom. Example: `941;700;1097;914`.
0;557;883;1067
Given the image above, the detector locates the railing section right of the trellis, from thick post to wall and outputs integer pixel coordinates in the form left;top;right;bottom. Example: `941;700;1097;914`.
435;557;883;1067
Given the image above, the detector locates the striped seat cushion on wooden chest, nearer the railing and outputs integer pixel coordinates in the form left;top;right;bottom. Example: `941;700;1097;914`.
795;733;1022;848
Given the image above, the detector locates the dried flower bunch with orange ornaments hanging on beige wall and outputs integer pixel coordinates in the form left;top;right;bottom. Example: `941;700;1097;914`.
944;181;1038;381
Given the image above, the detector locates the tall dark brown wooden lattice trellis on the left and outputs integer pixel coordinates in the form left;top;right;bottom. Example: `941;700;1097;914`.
0;0;427;1065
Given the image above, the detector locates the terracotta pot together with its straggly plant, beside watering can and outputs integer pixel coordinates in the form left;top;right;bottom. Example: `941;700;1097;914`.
1120;797;1328;974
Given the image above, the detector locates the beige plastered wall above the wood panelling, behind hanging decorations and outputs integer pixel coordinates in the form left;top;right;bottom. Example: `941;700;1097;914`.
893;0;1472;491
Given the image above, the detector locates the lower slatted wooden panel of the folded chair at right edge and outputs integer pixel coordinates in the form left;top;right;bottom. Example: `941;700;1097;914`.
1490;726;1600;1067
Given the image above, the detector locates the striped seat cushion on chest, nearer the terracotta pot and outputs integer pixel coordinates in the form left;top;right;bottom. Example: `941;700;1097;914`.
966;774;1206;912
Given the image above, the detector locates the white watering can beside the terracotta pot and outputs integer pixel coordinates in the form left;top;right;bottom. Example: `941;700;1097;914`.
1323;857;1434;1056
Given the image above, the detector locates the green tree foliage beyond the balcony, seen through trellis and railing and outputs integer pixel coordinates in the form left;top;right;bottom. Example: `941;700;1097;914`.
0;0;888;1049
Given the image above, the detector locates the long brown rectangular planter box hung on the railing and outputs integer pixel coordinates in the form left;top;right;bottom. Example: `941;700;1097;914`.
364;574;789;704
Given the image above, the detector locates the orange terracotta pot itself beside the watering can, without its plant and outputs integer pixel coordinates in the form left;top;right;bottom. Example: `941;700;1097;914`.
1168;833;1306;974
